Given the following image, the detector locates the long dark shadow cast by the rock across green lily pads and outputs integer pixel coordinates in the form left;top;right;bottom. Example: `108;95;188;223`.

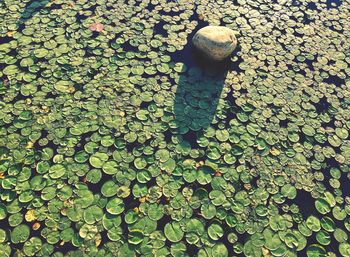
173;47;230;134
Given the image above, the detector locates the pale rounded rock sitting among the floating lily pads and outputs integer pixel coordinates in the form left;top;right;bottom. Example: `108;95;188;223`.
192;26;237;61
